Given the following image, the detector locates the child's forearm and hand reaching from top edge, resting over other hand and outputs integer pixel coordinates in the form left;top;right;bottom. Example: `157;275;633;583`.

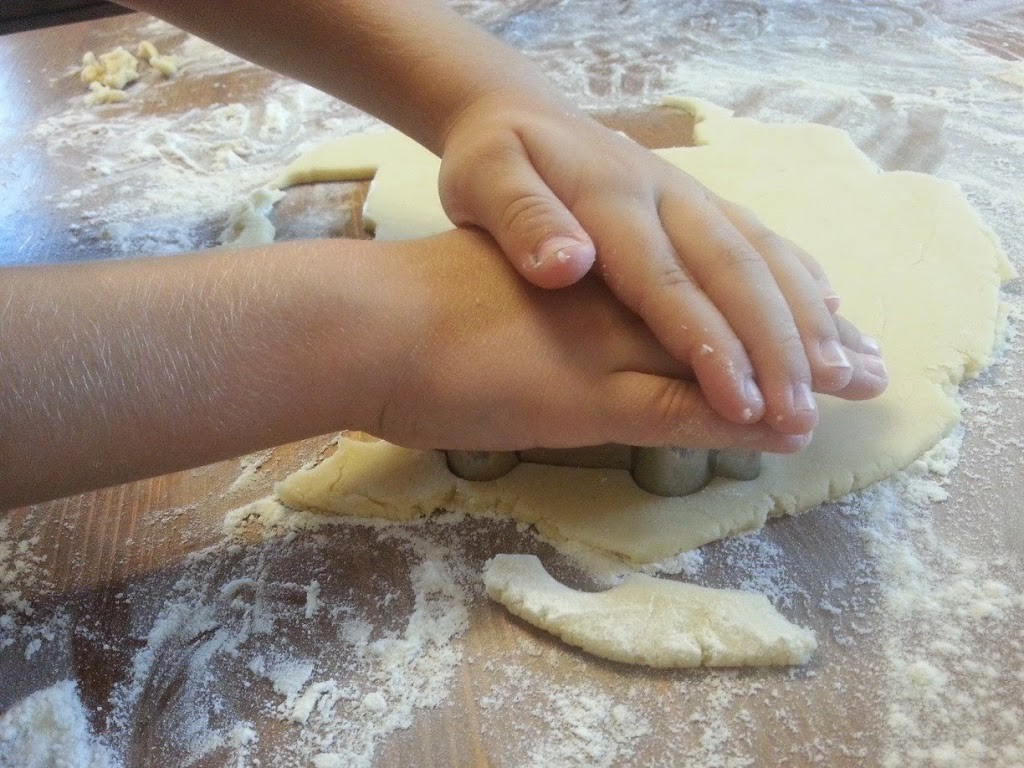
119;0;886;442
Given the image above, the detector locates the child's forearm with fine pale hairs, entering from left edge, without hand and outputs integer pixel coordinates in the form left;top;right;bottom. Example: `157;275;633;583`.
0;241;403;508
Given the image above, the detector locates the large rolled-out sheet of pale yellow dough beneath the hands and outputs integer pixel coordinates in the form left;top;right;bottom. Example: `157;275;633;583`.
278;100;1014;563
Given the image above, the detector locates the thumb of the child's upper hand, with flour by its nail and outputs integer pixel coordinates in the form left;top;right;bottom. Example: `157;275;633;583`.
440;147;596;288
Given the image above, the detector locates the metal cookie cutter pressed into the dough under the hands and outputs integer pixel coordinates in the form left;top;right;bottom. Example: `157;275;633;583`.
444;443;761;497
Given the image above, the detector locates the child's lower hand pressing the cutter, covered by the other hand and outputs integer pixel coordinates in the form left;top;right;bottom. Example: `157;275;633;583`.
374;229;857;453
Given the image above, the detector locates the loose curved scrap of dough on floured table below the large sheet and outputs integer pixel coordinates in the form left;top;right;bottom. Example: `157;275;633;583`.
483;555;817;668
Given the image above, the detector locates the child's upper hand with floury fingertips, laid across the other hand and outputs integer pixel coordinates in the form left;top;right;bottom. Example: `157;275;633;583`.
440;92;887;435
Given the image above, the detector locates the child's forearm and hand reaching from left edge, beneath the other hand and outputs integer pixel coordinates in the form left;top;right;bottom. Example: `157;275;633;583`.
0;230;807;509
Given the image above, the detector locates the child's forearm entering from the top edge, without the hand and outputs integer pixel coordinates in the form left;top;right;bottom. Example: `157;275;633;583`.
124;0;550;153
